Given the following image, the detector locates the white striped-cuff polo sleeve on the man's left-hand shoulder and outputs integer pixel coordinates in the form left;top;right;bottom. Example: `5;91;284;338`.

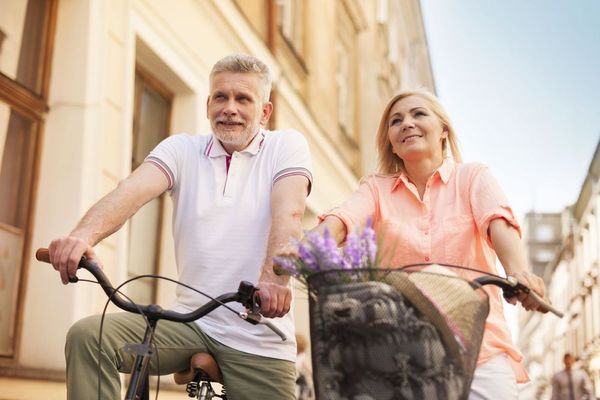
144;134;191;191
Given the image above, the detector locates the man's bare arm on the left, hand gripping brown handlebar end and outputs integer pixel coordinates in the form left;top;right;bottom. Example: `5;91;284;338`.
48;163;169;284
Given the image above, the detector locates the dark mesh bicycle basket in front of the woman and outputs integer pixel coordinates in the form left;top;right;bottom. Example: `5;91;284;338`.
308;270;489;400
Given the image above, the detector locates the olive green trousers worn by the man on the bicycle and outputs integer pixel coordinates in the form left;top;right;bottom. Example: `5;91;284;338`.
65;313;296;400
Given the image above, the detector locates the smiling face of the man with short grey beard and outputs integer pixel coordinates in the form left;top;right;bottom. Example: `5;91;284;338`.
206;72;273;154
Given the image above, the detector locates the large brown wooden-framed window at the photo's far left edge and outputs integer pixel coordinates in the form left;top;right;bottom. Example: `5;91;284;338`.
0;0;57;357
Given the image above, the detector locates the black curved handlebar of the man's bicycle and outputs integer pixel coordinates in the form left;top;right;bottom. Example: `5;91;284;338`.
35;248;287;341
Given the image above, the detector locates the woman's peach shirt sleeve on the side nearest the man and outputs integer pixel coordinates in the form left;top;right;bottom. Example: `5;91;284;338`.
319;177;377;238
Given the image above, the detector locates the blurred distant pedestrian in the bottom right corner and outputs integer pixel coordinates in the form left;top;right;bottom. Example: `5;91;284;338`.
552;353;595;400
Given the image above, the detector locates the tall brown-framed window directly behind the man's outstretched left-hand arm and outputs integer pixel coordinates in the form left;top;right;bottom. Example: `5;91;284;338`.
128;67;173;304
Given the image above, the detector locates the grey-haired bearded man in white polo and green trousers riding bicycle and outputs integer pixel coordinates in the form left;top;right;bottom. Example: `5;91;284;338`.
49;55;312;400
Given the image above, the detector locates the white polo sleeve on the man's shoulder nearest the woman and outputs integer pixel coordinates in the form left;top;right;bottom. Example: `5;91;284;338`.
273;130;313;194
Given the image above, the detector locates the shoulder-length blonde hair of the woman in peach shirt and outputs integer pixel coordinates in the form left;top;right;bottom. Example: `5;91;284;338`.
377;89;462;175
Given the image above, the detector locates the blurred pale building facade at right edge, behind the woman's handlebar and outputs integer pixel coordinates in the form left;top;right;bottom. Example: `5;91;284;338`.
519;139;600;399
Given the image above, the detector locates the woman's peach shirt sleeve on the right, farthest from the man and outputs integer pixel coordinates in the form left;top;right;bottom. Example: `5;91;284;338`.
469;165;521;246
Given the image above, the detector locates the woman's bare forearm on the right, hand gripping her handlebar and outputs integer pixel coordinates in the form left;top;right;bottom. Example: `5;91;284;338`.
489;218;545;310
